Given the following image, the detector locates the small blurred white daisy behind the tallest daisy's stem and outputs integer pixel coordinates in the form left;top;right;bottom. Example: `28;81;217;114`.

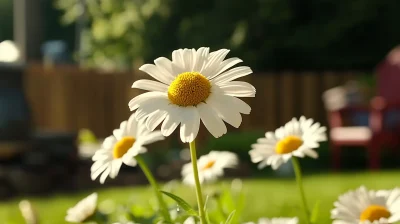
182;151;239;185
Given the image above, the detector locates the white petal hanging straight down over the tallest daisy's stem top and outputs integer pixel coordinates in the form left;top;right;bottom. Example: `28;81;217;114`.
180;107;200;142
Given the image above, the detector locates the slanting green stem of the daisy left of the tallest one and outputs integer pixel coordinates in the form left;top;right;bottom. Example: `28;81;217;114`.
135;156;172;223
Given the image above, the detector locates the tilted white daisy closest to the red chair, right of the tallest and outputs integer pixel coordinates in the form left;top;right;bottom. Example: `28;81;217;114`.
249;116;327;170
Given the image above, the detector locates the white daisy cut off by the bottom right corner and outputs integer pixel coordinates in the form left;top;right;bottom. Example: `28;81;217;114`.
331;186;400;224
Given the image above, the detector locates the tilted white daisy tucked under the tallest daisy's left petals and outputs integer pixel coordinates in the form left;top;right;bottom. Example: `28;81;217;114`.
90;115;164;184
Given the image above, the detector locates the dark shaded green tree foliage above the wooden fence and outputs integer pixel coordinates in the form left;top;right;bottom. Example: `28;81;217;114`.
56;0;400;70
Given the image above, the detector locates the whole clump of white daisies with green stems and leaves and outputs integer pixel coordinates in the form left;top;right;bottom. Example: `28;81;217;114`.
57;47;400;224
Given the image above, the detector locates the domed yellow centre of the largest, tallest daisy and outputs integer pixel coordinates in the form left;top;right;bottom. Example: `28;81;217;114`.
168;72;211;107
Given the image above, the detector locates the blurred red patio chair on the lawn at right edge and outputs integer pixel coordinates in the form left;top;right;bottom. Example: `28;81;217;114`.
323;47;400;170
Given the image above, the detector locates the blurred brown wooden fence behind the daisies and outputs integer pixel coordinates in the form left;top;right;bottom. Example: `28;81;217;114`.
25;64;359;143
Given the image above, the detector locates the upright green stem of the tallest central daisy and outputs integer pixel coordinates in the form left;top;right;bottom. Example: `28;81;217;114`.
189;140;207;224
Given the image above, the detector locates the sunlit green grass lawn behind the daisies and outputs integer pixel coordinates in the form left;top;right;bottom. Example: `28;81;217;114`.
0;171;400;224
